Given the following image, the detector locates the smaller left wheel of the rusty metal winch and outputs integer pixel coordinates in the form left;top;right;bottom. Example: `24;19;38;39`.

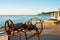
5;20;14;35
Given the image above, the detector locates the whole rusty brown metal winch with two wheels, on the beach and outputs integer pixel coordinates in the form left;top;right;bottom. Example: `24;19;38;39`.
5;18;43;40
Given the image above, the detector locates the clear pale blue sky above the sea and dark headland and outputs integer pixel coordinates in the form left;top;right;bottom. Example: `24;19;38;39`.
0;0;60;15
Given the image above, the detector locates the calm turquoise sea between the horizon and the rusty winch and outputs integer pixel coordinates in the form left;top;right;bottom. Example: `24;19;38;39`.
0;15;51;27
